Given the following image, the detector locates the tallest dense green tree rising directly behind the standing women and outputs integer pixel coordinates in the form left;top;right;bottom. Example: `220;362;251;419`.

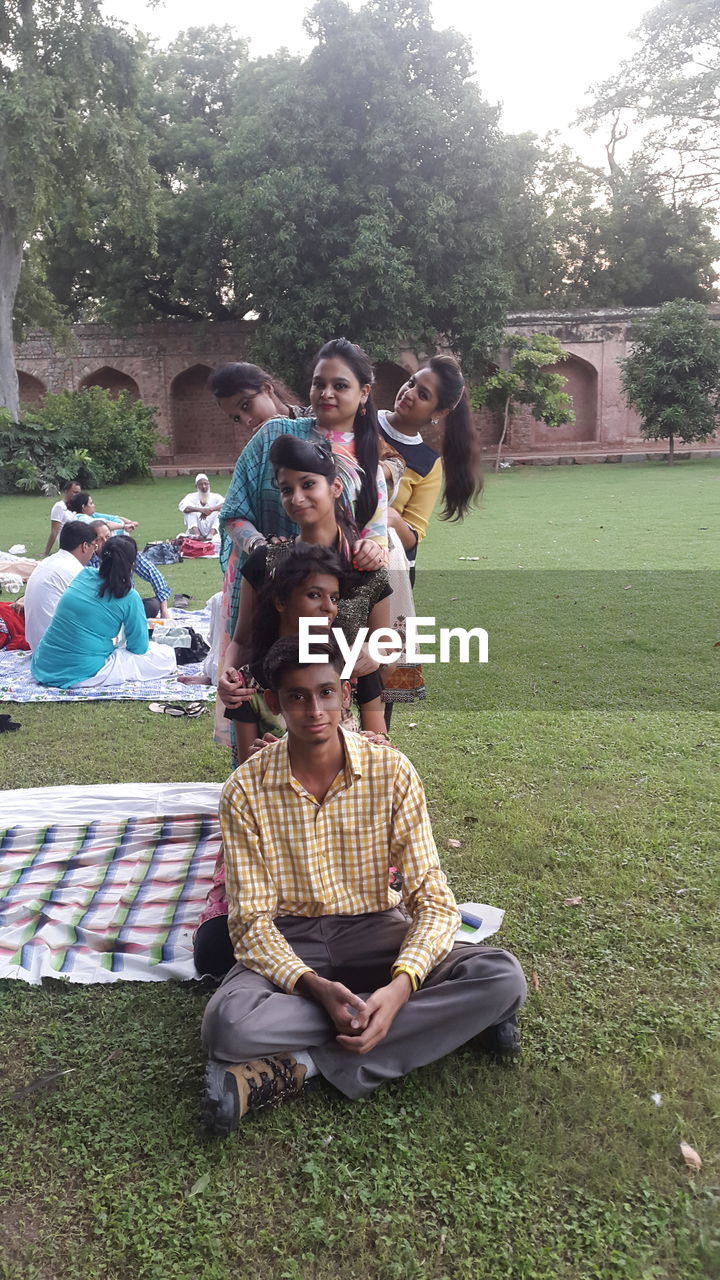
228;0;507;375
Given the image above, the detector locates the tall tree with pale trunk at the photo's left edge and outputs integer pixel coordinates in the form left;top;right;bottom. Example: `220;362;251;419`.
0;0;152;417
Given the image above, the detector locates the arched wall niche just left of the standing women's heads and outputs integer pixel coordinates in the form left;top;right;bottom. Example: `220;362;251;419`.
170;364;238;465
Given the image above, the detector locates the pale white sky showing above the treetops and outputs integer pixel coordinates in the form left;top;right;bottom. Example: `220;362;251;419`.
105;0;656;165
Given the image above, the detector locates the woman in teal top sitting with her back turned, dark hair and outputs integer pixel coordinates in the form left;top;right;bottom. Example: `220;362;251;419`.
31;534;176;689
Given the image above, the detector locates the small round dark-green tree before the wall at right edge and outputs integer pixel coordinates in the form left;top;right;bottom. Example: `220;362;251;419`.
621;298;720;462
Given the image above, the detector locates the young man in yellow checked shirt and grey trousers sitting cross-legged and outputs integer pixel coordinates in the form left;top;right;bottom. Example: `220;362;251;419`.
202;636;525;1135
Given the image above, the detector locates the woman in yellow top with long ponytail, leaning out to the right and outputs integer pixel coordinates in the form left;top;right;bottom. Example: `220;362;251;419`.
378;356;483;577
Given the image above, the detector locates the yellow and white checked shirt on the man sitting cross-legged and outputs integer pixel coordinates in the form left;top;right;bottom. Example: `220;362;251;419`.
220;730;460;991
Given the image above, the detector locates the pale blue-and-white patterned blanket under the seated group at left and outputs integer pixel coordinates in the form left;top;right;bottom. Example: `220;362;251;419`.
0;608;215;703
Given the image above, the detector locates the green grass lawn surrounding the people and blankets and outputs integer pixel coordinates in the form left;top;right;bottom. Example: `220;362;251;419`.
0;461;720;1280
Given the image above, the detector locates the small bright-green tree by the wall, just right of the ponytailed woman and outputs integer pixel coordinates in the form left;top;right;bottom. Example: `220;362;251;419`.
474;333;575;471
